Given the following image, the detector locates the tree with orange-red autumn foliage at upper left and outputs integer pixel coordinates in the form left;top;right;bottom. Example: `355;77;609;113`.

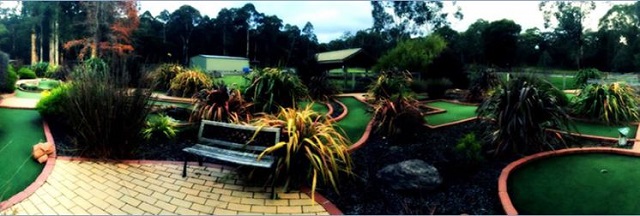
64;0;140;60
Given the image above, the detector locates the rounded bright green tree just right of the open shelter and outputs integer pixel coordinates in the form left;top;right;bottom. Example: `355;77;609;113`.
373;35;447;72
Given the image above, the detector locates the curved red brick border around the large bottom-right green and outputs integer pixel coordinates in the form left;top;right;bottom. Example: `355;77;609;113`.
498;147;640;215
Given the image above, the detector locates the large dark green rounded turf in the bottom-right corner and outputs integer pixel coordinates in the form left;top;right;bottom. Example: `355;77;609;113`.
508;153;640;215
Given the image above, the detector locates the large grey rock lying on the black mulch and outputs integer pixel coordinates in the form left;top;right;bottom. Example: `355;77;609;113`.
376;159;442;191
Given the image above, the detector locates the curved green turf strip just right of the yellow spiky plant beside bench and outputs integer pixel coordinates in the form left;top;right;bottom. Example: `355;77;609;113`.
336;97;372;142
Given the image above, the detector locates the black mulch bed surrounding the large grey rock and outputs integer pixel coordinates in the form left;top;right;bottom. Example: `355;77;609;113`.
320;122;513;214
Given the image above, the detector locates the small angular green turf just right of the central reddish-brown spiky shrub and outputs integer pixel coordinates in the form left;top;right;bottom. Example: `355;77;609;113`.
424;101;478;126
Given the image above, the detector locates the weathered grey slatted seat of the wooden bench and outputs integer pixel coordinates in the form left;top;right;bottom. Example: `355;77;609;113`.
183;144;275;168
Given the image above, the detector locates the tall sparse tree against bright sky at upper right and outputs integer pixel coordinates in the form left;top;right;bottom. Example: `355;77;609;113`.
539;1;596;68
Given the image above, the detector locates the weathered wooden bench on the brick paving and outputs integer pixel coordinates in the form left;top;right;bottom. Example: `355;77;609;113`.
182;120;280;198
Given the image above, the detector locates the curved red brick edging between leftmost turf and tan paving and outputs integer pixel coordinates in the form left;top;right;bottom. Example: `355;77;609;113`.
0;120;56;211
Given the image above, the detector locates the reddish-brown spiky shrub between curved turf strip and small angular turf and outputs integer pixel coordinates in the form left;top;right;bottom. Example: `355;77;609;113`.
374;95;426;136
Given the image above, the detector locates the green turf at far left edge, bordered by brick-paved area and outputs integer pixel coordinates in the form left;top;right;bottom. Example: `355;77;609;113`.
0;108;46;201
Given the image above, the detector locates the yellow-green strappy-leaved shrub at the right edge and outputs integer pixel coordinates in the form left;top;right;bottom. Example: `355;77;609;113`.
573;82;638;124
